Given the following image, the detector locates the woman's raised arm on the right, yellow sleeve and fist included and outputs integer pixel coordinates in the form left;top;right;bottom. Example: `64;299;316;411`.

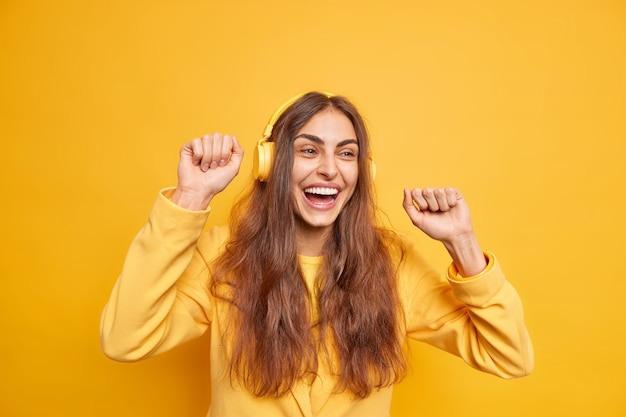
401;188;533;378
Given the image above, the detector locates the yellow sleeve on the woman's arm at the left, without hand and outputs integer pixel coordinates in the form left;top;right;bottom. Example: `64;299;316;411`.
100;190;223;362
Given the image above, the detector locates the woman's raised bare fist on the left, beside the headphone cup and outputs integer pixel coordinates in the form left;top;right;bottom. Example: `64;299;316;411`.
172;133;243;210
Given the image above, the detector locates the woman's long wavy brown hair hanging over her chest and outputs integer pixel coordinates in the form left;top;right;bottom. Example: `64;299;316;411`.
211;92;406;398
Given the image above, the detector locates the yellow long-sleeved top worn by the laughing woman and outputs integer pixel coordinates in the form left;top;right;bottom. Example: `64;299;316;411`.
101;191;533;417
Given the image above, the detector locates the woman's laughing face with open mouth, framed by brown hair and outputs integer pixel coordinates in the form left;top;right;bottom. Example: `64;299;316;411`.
292;109;359;249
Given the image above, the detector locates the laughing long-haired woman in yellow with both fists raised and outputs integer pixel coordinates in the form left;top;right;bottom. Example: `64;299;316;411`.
101;92;533;417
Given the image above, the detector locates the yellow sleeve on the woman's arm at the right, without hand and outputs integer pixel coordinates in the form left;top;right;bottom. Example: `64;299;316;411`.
400;237;534;378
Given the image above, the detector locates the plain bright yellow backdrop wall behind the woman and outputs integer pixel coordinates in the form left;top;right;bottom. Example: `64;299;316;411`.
0;0;626;417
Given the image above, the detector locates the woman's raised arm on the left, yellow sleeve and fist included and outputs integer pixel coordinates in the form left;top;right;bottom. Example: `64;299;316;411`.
100;135;243;361
